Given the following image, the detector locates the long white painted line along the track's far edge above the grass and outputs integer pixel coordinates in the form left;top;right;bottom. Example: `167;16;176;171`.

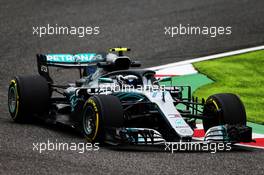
149;45;264;71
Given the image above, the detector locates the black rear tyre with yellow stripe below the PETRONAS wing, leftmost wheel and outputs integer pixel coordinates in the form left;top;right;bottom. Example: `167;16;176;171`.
8;75;50;122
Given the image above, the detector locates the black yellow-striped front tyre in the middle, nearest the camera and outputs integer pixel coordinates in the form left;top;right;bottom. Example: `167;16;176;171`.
81;95;124;143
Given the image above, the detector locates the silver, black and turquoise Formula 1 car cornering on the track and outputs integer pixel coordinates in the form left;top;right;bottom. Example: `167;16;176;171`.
8;47;252;145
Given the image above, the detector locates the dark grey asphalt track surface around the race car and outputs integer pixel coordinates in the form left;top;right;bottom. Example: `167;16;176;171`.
0;0;264;174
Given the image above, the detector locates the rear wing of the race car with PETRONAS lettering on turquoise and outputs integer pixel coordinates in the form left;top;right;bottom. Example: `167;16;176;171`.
37;53;105;82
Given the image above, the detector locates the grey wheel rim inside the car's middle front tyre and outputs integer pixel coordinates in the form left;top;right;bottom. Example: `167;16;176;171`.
83;106;96;135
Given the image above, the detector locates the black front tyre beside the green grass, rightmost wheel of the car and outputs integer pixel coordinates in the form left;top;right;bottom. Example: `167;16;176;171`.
203;93;246;131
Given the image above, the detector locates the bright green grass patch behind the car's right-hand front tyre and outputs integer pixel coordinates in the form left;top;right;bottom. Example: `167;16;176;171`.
194;50;264;124
